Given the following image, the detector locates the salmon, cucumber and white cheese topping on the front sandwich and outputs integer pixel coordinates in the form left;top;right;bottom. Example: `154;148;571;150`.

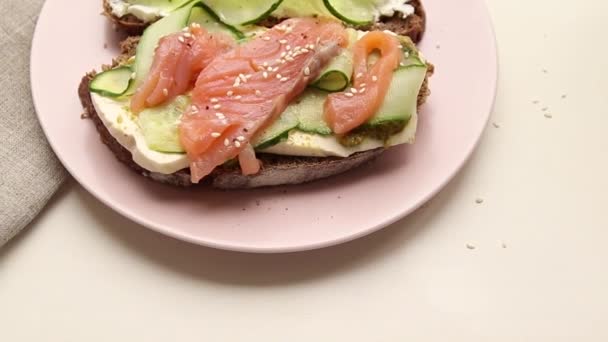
90;0;428;183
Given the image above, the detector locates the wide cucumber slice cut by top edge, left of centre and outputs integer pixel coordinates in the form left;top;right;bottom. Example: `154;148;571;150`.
205;0;283;26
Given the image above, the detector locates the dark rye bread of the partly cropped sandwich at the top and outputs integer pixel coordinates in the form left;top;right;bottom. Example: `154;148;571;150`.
103;0;426;44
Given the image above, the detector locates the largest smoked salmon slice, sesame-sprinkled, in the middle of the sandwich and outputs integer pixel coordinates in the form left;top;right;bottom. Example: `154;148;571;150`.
179;18;348;183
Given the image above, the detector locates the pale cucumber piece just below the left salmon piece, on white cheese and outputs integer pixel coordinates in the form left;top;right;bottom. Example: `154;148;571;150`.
137;96;190;153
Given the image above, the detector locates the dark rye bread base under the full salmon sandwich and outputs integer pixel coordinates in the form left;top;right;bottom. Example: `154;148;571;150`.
78;31;434;189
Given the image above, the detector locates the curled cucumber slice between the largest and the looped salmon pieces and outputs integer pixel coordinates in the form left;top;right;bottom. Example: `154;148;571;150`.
312;29;358;92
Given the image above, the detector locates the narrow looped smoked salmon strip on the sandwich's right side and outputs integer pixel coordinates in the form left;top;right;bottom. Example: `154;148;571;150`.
325;31;403;134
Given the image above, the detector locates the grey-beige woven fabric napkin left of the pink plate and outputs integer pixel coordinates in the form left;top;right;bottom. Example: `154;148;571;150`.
0;0;66;246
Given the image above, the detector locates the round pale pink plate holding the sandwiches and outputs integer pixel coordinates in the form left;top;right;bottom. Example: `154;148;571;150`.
31;0;497;252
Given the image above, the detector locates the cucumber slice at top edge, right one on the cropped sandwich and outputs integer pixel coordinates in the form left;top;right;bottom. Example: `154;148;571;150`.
323;0;376;26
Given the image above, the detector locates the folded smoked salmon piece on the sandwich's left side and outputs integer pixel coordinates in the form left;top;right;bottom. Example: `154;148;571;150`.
131;24;236;114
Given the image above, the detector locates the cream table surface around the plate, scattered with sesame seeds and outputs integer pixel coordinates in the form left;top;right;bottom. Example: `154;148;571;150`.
0;0;608;342
